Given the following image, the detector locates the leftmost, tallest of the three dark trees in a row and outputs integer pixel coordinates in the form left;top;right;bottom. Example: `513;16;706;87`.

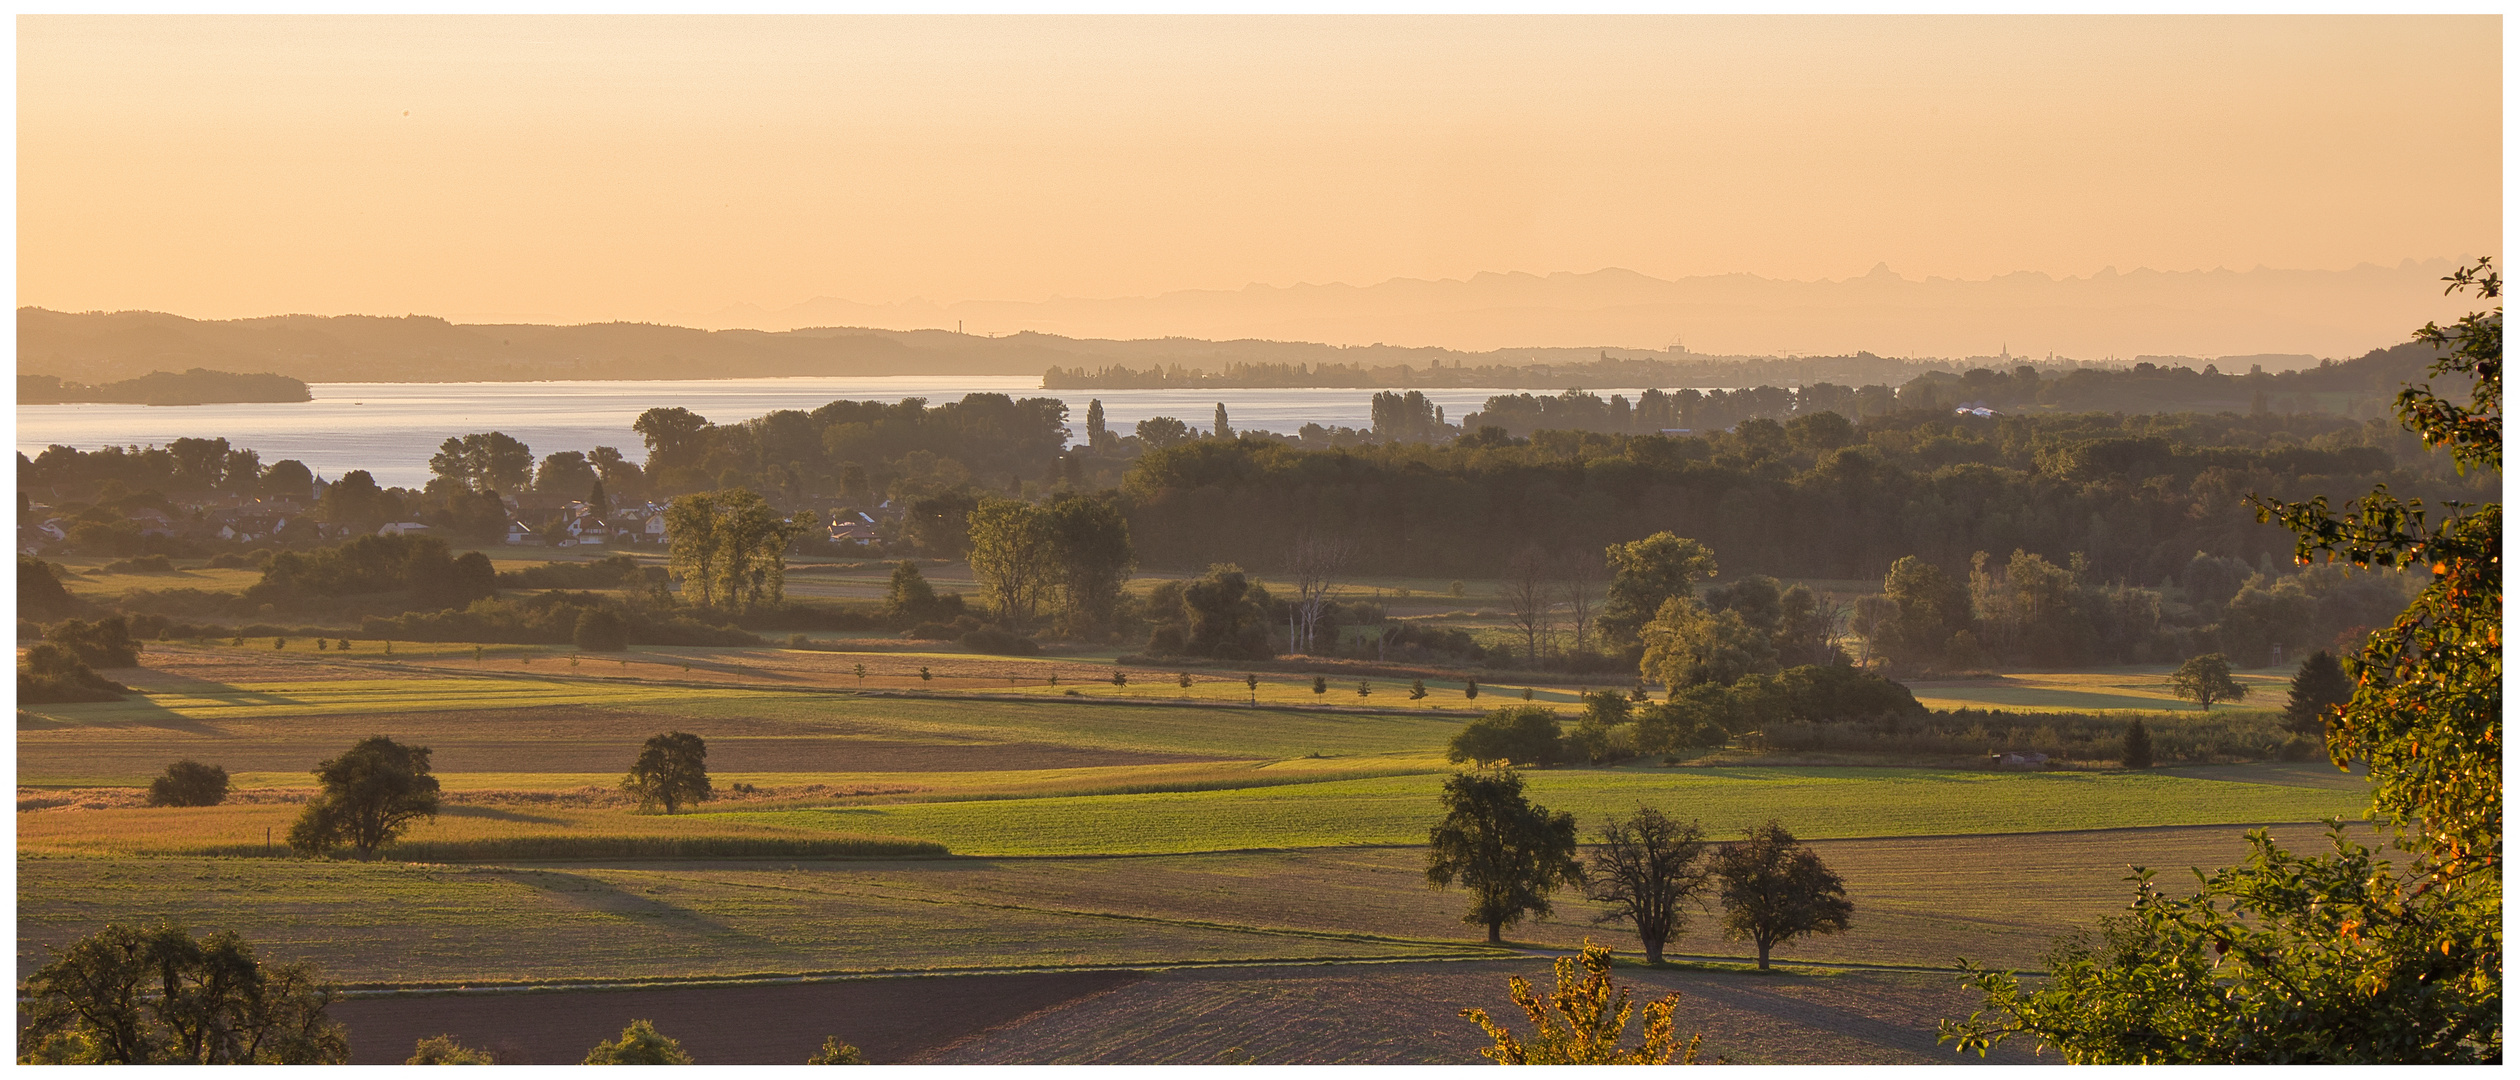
1426;768;1583;944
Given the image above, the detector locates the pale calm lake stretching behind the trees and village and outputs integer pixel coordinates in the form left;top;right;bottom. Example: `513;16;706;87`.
18;375;1683;488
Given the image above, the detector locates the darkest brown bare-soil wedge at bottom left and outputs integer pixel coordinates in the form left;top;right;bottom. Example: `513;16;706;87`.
333;972;1144;1065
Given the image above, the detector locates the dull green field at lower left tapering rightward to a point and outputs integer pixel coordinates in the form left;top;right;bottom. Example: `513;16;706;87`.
18;856;1484;987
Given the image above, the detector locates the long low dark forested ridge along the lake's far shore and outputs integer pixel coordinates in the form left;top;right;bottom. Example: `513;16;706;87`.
18;307;2378;390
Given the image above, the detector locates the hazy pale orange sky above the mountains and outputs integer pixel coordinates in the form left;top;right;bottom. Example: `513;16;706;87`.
18;15;2502;322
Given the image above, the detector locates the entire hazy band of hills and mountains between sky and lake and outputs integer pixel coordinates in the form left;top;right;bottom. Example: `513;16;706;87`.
18;259;2460;388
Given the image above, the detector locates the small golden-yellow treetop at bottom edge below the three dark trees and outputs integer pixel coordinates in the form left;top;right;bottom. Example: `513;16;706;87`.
1462;939;1704;1065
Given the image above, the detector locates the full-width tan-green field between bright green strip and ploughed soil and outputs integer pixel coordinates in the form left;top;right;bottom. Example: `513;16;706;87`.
18;826;2358;984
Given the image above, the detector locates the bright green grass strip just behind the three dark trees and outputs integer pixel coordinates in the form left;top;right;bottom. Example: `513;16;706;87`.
723;768;2366;856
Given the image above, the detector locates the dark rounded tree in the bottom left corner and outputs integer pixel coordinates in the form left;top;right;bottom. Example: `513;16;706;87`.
18;921;350;1065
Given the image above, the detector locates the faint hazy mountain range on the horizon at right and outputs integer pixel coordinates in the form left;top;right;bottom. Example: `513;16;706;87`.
683;259;2457;363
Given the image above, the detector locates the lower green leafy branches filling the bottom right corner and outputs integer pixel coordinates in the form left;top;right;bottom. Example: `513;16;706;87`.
1943;826;2502;1065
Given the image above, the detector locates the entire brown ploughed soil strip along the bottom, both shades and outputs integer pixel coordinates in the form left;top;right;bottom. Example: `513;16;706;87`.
335;959;2054;1065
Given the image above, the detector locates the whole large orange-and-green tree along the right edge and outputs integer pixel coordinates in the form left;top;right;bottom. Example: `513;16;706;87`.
1943;262;2502;1065
